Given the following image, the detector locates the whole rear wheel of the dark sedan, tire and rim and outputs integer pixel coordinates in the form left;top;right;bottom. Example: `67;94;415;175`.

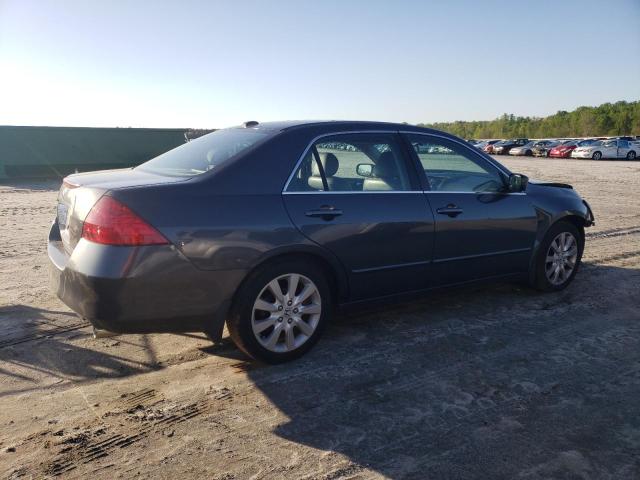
227;259;332;363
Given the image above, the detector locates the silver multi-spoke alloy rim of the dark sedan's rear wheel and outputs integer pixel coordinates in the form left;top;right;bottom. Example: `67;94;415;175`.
251;273;322;353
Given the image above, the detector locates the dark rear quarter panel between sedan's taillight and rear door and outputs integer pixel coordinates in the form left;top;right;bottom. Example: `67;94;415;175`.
110;132;347;294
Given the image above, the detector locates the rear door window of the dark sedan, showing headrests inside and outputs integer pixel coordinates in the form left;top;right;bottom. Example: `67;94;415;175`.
286;133;411;192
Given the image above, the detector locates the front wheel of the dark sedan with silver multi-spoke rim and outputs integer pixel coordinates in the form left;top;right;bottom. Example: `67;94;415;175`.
534;221;584;292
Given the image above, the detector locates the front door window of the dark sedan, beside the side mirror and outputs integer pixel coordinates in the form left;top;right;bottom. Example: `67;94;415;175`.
407;135;505;193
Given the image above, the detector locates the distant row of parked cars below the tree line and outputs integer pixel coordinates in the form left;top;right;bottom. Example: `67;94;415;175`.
469;136;640;160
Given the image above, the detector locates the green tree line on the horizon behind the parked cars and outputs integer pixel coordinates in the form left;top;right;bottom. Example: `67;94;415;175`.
419;101;640;138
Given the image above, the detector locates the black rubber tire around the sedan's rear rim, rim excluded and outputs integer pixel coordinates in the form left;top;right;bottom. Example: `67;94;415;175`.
227;257;333;364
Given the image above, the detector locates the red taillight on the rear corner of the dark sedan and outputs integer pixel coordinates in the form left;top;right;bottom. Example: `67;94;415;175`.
82;195;169;246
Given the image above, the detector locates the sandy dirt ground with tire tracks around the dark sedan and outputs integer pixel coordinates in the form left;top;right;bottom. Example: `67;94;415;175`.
0;157;640;479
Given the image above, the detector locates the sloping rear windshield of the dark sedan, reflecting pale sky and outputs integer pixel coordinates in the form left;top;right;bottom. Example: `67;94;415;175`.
136;128;268;177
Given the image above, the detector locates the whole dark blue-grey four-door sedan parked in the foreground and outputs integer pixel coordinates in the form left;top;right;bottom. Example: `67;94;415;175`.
48;122;593;363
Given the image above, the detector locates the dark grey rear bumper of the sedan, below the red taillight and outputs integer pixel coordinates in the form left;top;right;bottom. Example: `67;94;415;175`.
48;222;246;336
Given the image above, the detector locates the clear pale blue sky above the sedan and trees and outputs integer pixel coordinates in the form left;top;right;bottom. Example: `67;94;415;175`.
0;0;640;128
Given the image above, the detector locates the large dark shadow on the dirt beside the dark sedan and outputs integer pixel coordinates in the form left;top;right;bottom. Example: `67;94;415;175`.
248;264;640;478
